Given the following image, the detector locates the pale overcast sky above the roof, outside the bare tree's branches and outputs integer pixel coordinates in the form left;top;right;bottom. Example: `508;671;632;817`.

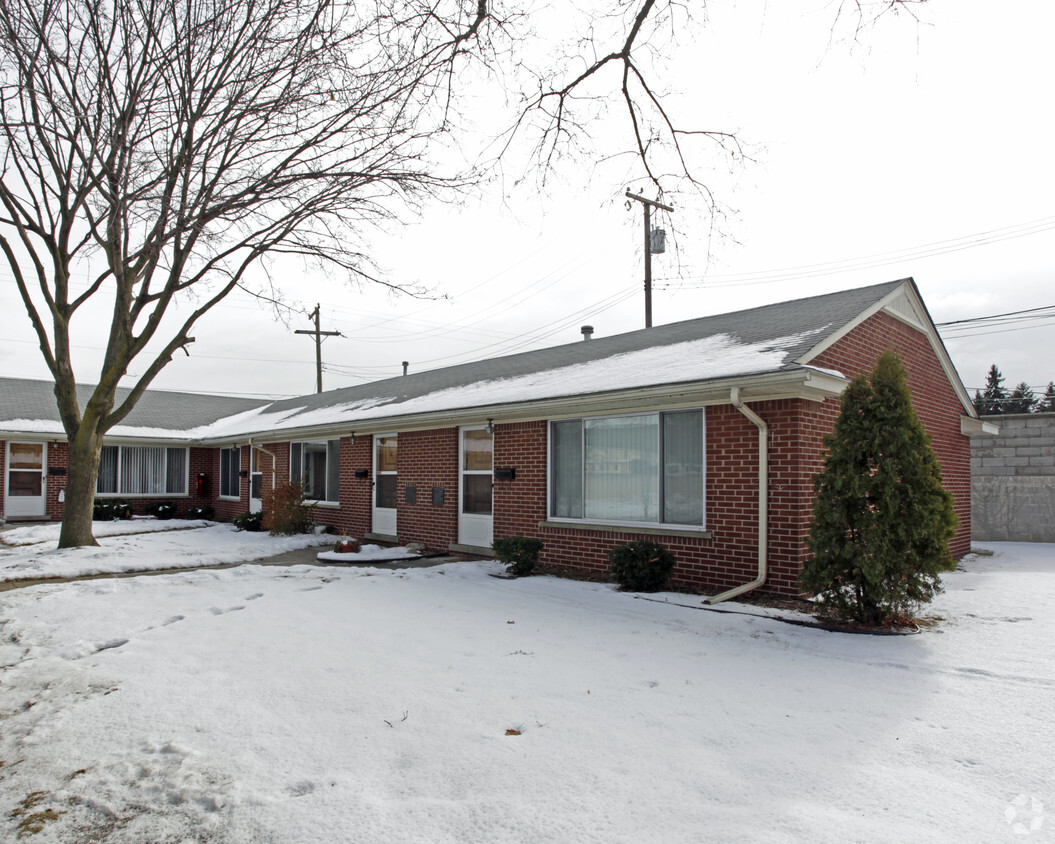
0;0;1055;403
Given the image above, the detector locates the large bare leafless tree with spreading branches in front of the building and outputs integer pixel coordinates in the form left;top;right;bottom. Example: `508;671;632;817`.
0;0;922;548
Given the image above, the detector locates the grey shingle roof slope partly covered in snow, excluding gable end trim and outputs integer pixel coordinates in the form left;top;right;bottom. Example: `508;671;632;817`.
0;280;914;441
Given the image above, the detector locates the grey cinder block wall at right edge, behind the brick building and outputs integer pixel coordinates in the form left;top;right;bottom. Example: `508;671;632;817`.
971;414;1055;542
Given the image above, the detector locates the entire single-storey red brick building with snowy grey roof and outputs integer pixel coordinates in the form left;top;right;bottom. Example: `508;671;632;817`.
0;280;985;593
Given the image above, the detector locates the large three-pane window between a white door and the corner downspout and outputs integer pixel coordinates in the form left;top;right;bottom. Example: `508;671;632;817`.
549;409;705;528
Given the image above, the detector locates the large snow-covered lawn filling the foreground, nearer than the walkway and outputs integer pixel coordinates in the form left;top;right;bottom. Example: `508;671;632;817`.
0;532;1055;844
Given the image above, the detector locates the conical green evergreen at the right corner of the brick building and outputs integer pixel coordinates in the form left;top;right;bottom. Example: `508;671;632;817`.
800;351;962;625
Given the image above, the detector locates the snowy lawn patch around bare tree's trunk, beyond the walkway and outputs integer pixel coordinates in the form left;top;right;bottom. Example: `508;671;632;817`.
0;519;333;580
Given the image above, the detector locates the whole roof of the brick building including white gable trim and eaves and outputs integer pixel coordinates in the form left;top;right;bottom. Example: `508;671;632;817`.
0;279;971;442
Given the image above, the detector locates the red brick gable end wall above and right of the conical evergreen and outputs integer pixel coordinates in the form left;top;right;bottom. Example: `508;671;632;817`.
813;313;971;558
